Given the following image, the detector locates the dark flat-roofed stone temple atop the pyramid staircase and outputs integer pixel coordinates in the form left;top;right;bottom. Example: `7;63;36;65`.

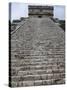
28;5;53;17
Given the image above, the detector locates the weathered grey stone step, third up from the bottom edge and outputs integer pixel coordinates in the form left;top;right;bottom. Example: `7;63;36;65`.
17;68;65;76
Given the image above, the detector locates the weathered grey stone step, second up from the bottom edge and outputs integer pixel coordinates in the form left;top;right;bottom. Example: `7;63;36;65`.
11;73;65;81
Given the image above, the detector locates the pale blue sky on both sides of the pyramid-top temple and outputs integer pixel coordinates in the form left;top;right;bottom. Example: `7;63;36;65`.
11;3;65;21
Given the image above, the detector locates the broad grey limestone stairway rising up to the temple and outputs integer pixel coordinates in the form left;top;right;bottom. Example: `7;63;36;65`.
10;6;65;87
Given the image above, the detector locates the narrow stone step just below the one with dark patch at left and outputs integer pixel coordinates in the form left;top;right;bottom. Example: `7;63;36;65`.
11;57;65;63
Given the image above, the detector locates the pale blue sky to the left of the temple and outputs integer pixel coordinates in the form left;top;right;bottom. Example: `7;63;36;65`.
11;3;28;20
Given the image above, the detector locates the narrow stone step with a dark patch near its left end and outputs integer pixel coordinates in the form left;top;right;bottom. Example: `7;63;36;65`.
13;52;64;59
